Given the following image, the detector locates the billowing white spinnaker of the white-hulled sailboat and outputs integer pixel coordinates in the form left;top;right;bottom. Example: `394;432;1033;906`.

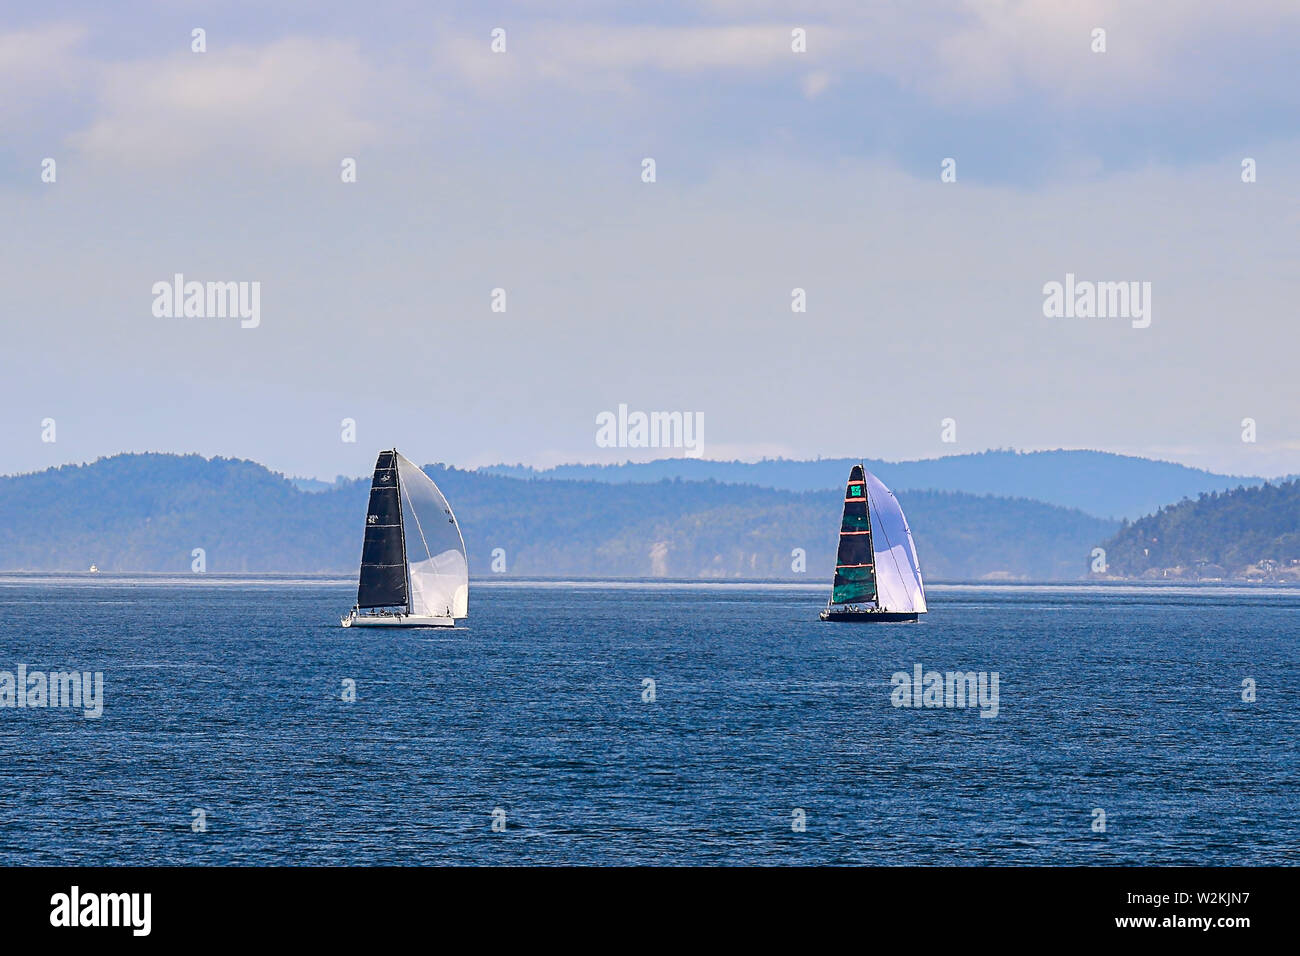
398;453;469;618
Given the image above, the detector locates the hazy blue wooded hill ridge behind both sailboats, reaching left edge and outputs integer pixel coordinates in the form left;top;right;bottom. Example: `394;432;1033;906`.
0;454;1119;581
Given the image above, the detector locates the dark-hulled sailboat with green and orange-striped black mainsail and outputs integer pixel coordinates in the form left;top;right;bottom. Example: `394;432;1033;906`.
820;464;926;622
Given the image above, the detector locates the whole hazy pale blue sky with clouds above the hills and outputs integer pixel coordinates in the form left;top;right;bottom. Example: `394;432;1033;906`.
0;0;1300;476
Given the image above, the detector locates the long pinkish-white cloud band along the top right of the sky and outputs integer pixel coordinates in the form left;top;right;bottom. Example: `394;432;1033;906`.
436;0;1300;109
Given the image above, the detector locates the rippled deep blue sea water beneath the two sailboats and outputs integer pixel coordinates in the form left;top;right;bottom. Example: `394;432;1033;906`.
0;575;1300;865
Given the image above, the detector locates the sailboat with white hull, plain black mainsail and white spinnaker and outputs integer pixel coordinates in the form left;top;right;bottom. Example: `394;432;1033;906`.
339;449;469;627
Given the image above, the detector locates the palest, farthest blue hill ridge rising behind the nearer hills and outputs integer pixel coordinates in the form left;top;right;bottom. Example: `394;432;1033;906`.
480;450;1264;520
